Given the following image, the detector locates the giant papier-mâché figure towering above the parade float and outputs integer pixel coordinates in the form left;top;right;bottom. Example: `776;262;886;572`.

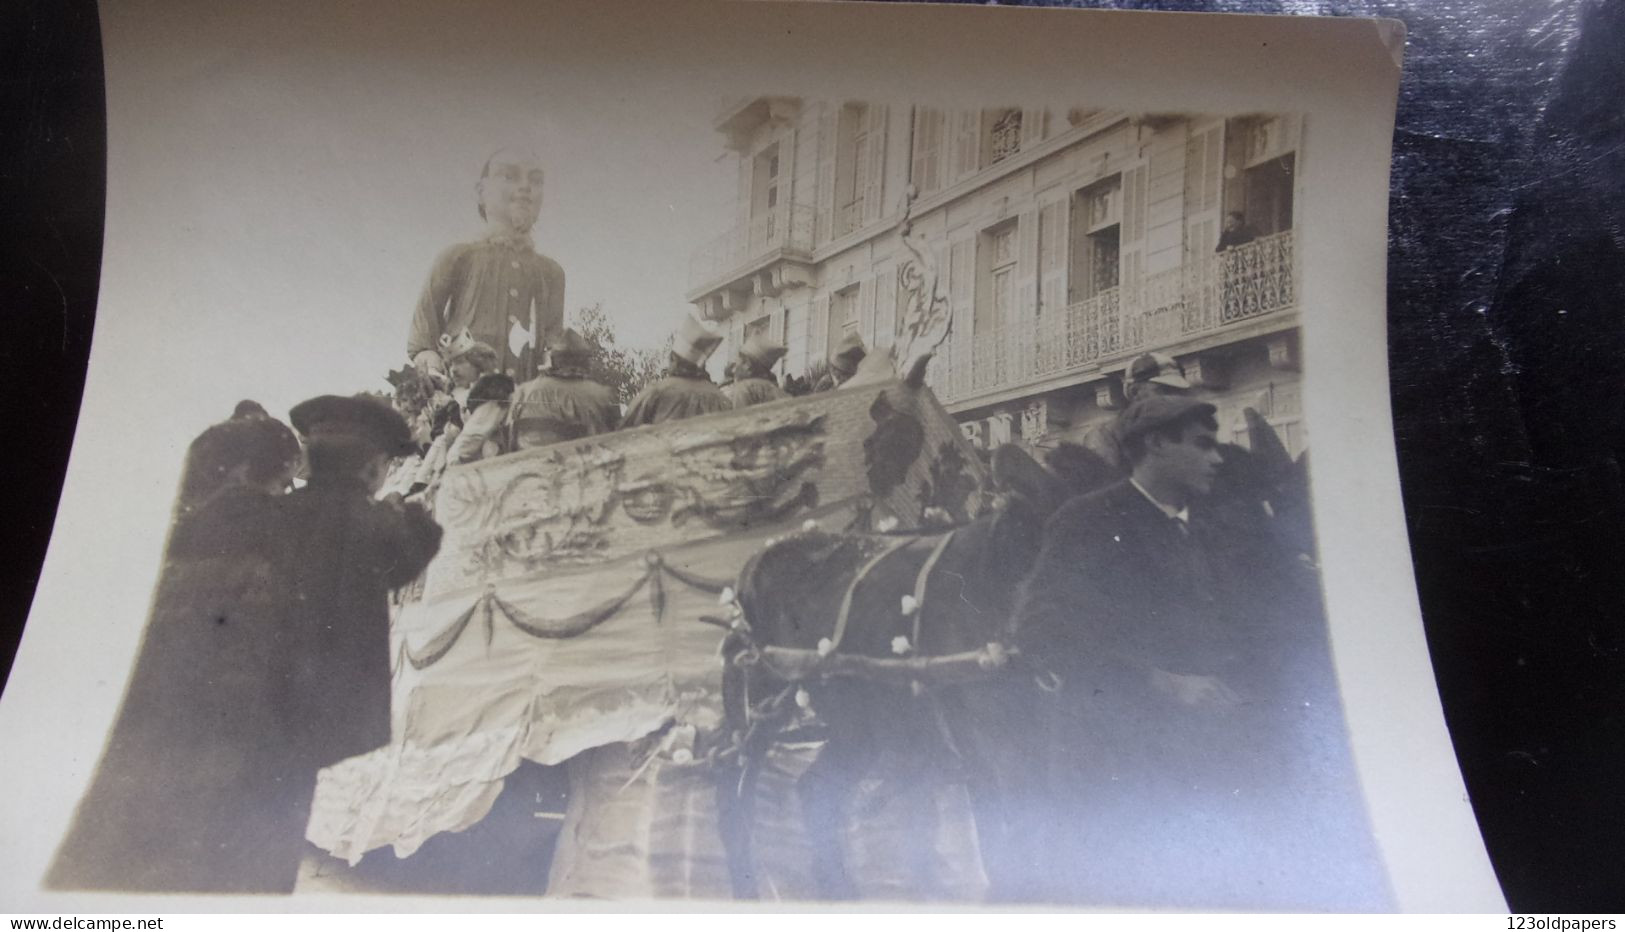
406;149;564;378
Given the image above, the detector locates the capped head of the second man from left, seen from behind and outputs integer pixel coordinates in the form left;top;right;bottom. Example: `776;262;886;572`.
288;395;414;492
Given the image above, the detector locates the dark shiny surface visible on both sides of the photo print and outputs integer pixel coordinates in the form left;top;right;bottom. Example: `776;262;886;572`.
0;0;1625;913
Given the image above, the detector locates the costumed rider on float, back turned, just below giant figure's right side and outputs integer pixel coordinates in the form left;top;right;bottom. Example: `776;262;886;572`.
509;328;621;450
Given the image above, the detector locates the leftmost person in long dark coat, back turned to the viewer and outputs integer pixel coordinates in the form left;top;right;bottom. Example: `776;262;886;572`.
46;409;314;893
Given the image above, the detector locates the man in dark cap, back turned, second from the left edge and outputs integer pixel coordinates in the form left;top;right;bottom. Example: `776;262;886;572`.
281;395;440;876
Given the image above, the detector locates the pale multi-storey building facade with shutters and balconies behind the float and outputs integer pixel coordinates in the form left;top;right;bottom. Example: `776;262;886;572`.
687;97;1307;453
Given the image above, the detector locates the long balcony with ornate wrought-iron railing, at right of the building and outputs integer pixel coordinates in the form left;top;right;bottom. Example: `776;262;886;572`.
926;231;1297;404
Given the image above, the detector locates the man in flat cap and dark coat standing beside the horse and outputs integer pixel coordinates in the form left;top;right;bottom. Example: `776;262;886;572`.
1014;393;1245;904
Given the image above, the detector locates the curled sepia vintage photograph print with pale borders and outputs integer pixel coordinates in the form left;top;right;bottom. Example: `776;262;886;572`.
7;3;1501;911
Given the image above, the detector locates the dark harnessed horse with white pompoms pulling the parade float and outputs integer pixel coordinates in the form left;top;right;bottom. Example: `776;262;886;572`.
723;447;1066;900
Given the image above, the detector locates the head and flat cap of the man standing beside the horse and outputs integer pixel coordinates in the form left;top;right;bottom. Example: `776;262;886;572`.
1118;395;1224;495
